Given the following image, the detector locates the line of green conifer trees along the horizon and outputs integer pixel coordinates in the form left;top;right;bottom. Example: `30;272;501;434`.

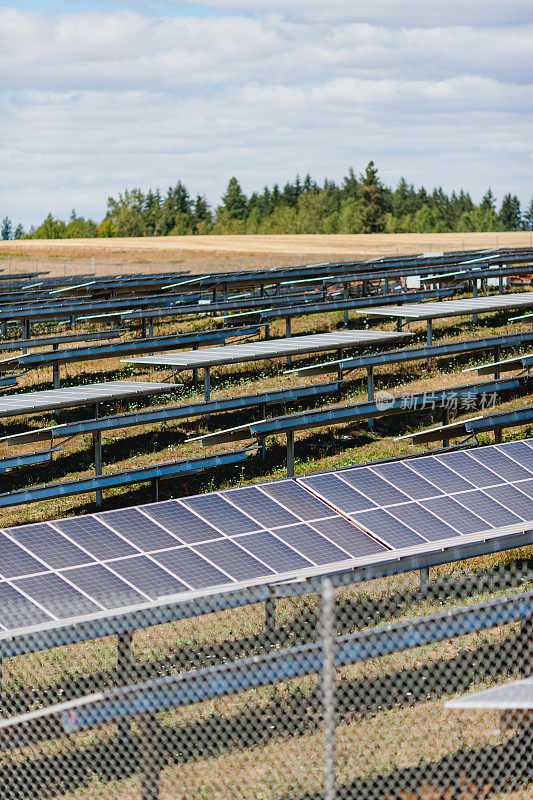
4;161;533;239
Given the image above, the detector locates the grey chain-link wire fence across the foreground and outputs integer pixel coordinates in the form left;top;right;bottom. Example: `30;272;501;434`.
0;551;533;800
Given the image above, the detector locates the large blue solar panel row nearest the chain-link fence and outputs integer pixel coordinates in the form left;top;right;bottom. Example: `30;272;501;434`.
0;440;533;635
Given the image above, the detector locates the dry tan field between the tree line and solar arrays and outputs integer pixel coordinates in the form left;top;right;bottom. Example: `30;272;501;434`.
0;231;533;275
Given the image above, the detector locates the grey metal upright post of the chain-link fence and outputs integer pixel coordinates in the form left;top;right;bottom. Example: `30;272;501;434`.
320;578;337;800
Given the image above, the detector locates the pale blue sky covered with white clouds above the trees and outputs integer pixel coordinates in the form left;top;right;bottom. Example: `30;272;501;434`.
0;0;533;228
